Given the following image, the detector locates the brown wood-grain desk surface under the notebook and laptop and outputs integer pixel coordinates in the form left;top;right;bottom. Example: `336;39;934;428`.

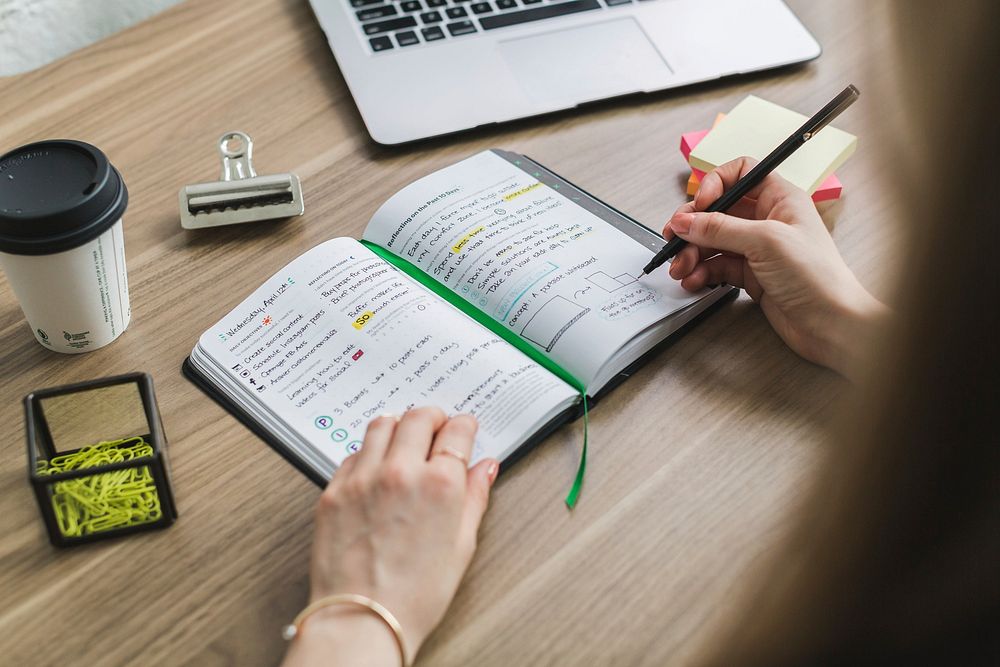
0;0;898;665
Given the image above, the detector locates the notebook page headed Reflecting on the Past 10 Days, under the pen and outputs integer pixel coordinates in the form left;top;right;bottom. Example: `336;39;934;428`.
364;151;707;387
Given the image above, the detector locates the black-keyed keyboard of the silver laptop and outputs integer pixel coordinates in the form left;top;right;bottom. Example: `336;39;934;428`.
350;0;633;52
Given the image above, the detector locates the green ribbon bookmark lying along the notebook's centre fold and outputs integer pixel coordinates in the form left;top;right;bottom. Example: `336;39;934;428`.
361;239;588;509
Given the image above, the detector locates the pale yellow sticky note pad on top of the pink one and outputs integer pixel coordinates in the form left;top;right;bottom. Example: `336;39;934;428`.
688;95;858;194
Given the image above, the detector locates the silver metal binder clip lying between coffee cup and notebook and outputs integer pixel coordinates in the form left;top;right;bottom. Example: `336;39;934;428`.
180;132;305;229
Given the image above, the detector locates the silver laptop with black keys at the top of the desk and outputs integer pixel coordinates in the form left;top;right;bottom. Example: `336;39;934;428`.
310;0;820;144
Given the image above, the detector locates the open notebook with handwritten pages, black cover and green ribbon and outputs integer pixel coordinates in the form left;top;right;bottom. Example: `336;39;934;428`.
184;150;734;494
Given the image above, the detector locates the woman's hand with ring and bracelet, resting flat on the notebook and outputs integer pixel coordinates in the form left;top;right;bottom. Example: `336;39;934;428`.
287;408;498;665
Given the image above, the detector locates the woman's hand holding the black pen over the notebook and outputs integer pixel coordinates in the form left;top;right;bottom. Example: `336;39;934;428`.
663;157;885;376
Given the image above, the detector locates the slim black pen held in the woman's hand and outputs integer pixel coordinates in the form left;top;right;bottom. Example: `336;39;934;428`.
642;85;861;274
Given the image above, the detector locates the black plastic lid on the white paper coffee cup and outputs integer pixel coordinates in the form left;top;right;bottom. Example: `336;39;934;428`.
0;139;128;255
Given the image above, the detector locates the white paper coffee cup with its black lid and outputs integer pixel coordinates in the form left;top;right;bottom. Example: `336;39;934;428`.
0;140;131;354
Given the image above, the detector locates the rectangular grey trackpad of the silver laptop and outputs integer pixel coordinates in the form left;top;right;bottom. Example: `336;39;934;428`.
498;16;671;106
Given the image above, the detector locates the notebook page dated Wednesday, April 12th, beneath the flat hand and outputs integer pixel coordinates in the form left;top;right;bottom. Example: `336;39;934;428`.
193;239;578;466
